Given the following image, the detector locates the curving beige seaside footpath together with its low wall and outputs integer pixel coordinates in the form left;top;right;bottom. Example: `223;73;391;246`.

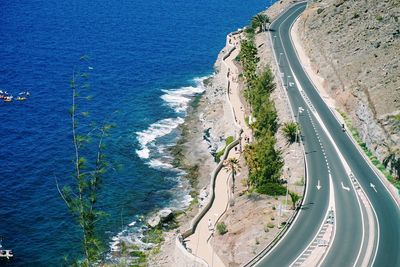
177;31;252;267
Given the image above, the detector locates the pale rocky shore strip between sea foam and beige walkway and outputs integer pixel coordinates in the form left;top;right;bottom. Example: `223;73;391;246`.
149;47;238;266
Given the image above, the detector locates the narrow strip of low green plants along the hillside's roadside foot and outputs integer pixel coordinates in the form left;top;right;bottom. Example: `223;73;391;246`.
338;110;400;194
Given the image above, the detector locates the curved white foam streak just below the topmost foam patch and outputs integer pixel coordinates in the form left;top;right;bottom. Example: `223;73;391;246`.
136;117;184;159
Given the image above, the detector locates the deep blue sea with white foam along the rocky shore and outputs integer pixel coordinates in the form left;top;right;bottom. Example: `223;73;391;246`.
0;0;269;266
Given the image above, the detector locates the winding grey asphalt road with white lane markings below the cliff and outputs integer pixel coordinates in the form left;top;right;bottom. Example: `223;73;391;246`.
255;3;400;266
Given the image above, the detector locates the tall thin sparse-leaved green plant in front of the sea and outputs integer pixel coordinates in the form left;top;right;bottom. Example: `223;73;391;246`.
56;56;111;266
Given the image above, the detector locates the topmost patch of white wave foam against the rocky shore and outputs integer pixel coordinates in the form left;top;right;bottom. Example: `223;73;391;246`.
161;76;208;113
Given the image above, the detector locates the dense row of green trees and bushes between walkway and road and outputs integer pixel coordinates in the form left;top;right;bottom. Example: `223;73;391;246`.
240;30;286;196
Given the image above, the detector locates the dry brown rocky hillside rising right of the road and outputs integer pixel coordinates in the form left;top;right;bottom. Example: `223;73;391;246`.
299;0;400;160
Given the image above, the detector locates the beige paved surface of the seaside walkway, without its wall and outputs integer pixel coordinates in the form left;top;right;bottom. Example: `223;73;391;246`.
186;34;251;267
